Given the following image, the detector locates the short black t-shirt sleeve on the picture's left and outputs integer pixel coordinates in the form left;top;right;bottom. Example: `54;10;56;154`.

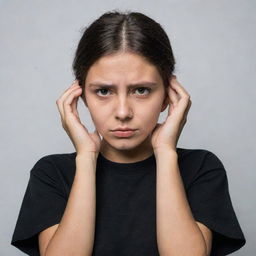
11;157;67;256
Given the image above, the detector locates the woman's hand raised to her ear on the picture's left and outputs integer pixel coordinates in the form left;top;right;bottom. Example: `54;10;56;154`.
56;80;101;156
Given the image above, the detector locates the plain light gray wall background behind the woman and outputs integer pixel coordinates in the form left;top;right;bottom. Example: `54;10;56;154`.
0;0;256;256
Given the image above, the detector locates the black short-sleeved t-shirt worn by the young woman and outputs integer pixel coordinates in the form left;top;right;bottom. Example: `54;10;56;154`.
11;148;246;256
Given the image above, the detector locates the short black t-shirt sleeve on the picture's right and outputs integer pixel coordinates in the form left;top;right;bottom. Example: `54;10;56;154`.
186;151;246;256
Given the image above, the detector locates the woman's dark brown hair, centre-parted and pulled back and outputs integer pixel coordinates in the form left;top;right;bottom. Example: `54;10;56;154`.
72;10;175;97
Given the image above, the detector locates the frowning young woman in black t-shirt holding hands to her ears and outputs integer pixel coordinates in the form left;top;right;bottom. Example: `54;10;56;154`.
11;11;245;256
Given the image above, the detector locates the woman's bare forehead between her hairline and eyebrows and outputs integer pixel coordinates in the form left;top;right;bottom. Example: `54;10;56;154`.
86;53;161;84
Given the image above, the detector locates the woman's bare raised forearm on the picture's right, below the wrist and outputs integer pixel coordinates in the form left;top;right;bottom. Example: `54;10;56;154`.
156;151;206;256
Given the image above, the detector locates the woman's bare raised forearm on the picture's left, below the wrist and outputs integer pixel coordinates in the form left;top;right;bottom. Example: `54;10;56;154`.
45;155;96;256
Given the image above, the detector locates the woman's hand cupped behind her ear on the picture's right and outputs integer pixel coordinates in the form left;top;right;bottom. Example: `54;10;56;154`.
151;75;192;152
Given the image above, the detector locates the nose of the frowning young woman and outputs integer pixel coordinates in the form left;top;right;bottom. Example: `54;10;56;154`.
115;96;133;120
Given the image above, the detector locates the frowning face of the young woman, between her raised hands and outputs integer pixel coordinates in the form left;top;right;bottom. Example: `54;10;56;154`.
85;53;168;157
